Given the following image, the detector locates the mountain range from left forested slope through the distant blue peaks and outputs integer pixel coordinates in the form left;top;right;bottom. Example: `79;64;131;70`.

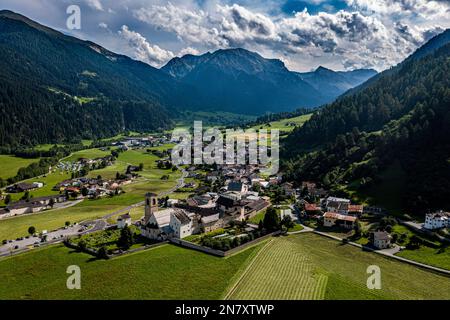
0;10;375;146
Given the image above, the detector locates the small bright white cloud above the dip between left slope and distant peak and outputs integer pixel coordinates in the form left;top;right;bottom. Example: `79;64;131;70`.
118;25;175;67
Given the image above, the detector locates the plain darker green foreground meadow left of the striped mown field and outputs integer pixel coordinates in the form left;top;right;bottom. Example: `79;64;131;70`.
0;245;258;300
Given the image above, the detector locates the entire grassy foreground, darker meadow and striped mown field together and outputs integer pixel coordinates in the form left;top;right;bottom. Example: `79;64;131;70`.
0;234;450;300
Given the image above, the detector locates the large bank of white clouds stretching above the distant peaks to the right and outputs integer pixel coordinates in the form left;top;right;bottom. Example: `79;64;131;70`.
133;0;450;70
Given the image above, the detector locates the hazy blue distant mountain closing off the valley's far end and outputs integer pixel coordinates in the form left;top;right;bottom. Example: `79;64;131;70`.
162;48;376;115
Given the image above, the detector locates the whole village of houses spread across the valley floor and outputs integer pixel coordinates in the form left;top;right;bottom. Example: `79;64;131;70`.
0;137;450;270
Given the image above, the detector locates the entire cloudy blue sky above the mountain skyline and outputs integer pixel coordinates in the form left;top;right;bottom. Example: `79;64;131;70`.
0;0;450;71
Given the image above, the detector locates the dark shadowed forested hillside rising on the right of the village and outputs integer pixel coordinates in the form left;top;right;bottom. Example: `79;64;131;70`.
286;40;450;214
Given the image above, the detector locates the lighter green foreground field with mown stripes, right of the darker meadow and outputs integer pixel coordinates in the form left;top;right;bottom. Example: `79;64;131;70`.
226;234;450;299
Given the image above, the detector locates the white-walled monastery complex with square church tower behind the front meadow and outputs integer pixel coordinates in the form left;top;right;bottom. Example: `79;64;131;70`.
137;176;270;239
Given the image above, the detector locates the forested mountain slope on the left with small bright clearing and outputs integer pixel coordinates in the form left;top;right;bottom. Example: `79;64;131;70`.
0;11;188;147
